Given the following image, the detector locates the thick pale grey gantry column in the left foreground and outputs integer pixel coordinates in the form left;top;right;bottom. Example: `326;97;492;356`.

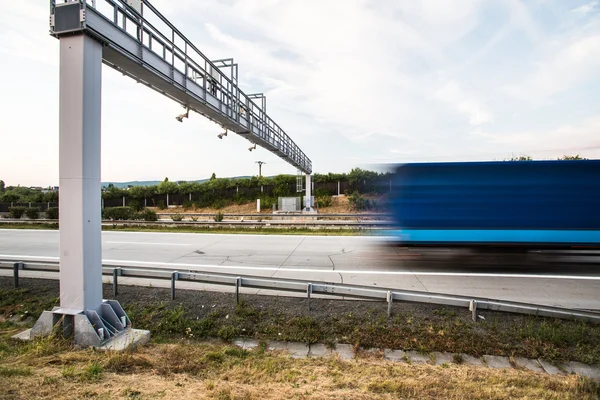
59;35;102;310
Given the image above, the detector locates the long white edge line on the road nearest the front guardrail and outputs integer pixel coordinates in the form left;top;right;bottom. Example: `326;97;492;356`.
0;254;600;281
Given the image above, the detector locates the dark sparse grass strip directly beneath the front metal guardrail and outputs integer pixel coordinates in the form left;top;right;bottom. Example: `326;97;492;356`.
0;277;600;364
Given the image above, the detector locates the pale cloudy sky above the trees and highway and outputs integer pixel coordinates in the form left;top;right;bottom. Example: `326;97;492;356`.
0;0;600;186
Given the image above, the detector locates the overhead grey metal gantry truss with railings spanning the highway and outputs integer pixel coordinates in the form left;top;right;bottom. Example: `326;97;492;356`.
50;0;312;174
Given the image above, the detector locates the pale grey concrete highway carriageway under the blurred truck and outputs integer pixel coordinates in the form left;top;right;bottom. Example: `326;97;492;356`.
0;229;600;310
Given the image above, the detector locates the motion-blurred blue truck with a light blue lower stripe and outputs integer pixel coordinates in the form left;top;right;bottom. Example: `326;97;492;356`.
390;160;600;248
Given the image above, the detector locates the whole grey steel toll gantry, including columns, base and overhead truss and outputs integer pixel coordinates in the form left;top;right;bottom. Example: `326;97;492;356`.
20;0;312;346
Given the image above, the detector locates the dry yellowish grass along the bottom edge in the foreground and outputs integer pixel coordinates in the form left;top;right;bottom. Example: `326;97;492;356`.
0;343;600;399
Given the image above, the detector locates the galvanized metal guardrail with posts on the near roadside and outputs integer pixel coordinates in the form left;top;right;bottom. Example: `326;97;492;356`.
0;258;600;323
